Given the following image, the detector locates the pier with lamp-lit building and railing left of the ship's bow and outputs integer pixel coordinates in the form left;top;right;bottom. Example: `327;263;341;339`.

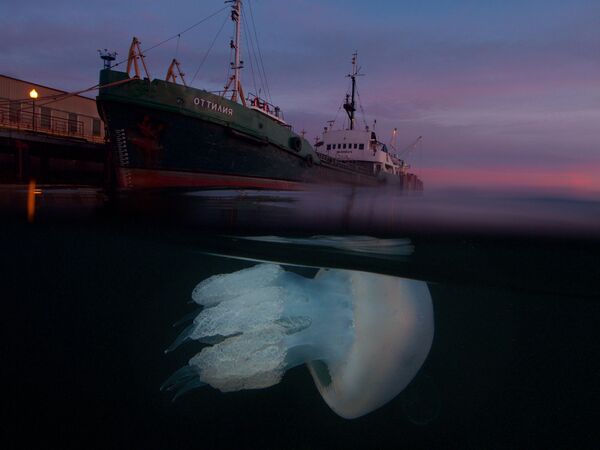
0;75;109;186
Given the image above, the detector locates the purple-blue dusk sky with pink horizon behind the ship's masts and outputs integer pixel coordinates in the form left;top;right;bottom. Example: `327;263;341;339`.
0;0;600;190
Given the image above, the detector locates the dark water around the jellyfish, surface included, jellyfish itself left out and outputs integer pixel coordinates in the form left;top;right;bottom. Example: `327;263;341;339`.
0;188;600;449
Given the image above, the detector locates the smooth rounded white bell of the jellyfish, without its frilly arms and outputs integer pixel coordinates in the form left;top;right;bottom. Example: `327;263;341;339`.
307;271;433;419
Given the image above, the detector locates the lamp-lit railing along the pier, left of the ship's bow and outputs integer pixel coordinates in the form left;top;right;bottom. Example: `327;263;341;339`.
0;103;104;143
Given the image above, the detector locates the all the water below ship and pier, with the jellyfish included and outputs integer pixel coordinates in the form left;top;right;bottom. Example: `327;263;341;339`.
0;186;600;449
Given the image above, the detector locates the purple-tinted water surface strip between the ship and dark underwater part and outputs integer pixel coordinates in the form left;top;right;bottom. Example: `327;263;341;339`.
0;186;600;239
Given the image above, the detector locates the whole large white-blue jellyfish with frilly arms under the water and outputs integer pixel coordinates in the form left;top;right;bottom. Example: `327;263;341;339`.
162;264;434;419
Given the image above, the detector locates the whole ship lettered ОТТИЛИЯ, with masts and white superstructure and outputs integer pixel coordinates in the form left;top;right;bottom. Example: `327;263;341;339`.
96;0;423;190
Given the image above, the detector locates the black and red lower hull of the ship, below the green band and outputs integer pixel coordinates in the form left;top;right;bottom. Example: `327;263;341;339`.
98;99;418;189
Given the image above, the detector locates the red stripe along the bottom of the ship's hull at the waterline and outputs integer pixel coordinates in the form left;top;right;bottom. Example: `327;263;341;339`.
118;168;305;191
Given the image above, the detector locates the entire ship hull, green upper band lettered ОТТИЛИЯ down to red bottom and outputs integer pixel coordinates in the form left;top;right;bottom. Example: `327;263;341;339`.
97;71;422;190
